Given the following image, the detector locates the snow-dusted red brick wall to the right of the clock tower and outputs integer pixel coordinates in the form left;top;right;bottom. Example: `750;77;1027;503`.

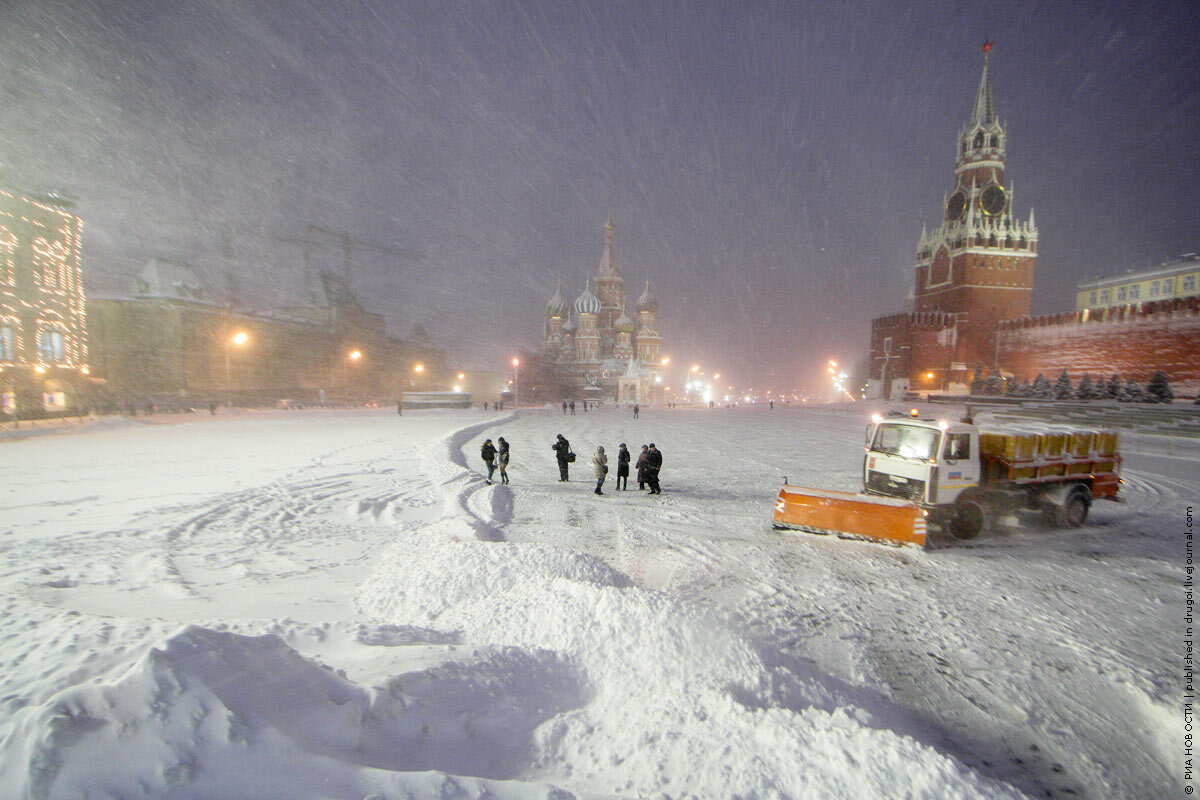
996;296;1200;396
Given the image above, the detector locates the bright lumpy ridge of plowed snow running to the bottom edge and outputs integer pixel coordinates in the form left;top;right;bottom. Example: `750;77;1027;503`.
356;531;1020;799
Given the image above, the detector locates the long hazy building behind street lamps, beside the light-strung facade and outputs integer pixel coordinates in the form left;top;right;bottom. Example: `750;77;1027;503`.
89;266;448;410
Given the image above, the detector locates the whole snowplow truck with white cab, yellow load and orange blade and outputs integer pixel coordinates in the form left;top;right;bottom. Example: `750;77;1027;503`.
774;416;1121;547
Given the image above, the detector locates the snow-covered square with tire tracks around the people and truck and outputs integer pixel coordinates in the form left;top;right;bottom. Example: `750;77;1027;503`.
0;405;1180;800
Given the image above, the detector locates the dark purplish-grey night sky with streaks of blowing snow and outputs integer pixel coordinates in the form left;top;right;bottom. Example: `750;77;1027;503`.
0;0;1200;386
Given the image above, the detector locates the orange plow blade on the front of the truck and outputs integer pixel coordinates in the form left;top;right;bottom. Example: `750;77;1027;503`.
773;486;925;547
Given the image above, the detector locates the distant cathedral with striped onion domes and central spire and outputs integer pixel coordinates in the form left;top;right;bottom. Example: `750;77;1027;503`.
542;216;662;402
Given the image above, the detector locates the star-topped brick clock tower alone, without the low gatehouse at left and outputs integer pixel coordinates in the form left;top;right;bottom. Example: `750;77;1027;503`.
912;42;1038;385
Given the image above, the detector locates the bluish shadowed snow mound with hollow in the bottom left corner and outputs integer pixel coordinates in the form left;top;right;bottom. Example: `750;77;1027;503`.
0;626;578;800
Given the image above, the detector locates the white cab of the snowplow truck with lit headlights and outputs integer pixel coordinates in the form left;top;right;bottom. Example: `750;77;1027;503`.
863;417;979;509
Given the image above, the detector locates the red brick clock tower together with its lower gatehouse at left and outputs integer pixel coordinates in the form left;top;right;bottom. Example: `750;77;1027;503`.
870;42;1038;397
